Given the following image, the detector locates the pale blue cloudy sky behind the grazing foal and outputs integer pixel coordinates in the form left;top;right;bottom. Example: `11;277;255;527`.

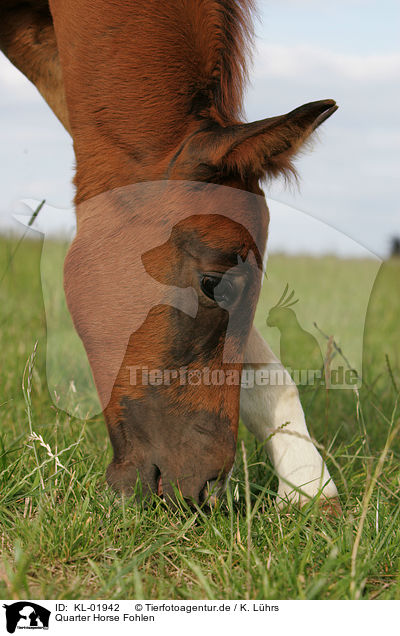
0;0;400;258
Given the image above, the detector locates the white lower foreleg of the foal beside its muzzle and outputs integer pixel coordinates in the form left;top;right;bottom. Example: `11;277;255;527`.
240;327;339;509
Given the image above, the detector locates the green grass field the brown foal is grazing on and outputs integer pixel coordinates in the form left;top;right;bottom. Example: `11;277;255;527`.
0;239;400;599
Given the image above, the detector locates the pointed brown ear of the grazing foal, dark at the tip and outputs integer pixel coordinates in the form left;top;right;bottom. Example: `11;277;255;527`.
206;99;338;178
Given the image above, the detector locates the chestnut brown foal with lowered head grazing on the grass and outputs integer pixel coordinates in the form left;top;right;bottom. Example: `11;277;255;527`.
0;0;337;502
